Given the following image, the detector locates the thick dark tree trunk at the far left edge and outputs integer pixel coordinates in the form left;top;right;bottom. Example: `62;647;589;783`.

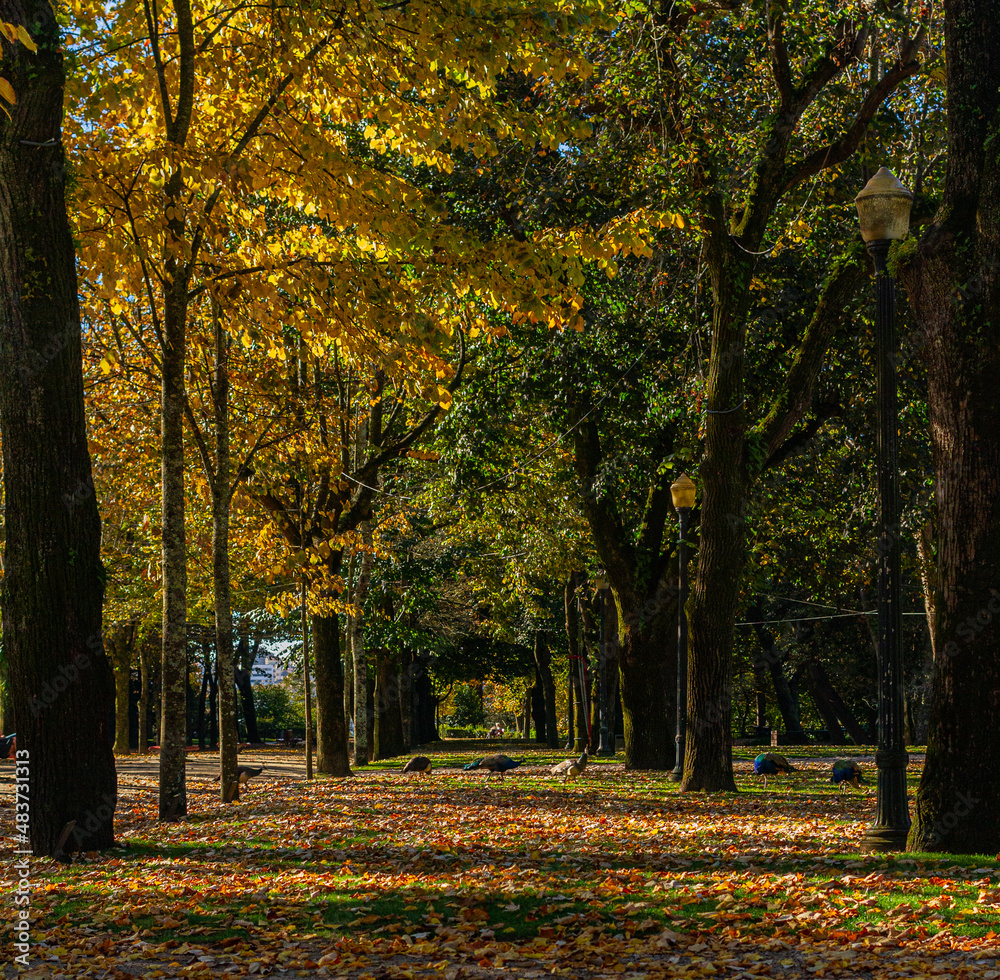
0;0;117;855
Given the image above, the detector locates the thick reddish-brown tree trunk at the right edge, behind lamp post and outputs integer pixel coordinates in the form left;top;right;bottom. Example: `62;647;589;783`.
890;0;1000;854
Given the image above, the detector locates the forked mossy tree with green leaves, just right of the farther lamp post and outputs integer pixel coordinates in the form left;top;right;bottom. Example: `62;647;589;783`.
580;2;924;790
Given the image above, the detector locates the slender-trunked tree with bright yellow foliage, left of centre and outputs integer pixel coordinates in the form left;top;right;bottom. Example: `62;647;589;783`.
74;0;600;819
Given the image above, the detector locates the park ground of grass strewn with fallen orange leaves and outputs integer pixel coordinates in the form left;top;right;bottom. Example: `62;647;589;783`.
0;742;1000;980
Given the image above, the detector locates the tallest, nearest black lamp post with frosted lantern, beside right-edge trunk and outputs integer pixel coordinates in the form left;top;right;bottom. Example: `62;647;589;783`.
855;167;913;851
